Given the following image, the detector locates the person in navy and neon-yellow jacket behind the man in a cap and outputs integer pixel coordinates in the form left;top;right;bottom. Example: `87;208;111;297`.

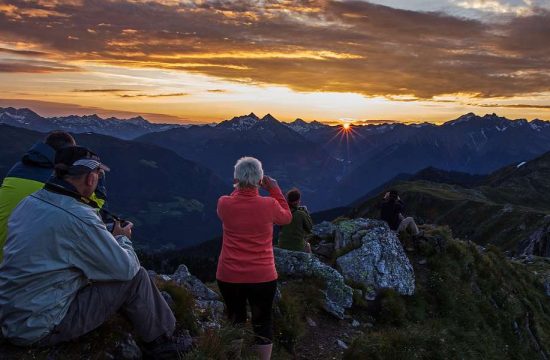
0;131;106;262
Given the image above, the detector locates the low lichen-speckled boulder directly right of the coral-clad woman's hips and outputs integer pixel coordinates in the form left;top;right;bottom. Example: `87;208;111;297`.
274;248;353;319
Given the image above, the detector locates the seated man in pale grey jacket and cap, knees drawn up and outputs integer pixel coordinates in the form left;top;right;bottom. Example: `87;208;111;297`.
0;146;182;359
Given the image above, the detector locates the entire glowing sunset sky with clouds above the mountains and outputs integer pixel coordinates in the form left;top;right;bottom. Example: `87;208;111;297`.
0;0;550;123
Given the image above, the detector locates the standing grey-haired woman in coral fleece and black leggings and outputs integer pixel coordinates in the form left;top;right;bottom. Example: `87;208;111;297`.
216;157;292;360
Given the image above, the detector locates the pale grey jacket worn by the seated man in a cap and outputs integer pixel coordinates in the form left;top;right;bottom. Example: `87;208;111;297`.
0;190;140;345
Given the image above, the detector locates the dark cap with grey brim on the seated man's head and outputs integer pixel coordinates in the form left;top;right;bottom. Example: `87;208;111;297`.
55;146;110;175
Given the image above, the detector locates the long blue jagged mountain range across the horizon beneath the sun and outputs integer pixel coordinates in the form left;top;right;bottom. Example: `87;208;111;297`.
0;104;550;211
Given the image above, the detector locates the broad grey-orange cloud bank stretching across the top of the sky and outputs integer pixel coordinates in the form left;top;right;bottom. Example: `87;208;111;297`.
0;0;550;101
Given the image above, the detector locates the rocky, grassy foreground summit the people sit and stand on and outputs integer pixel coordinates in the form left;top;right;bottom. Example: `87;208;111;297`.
0;218;550;360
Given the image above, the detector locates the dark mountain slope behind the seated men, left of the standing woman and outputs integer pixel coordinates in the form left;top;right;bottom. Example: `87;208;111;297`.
0;124;231;250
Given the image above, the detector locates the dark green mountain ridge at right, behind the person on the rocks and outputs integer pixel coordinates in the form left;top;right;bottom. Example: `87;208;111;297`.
349;152;550;257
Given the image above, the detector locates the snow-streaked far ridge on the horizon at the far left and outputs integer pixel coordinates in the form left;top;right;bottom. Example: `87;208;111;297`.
0;107;182;140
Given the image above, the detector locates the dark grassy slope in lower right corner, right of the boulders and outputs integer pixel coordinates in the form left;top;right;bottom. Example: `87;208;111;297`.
344;228;550;360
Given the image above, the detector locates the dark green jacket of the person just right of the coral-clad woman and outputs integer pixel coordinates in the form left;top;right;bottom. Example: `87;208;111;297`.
279;208;313;251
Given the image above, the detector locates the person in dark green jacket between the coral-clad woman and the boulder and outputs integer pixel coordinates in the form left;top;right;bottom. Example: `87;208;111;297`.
279;189;313;253
